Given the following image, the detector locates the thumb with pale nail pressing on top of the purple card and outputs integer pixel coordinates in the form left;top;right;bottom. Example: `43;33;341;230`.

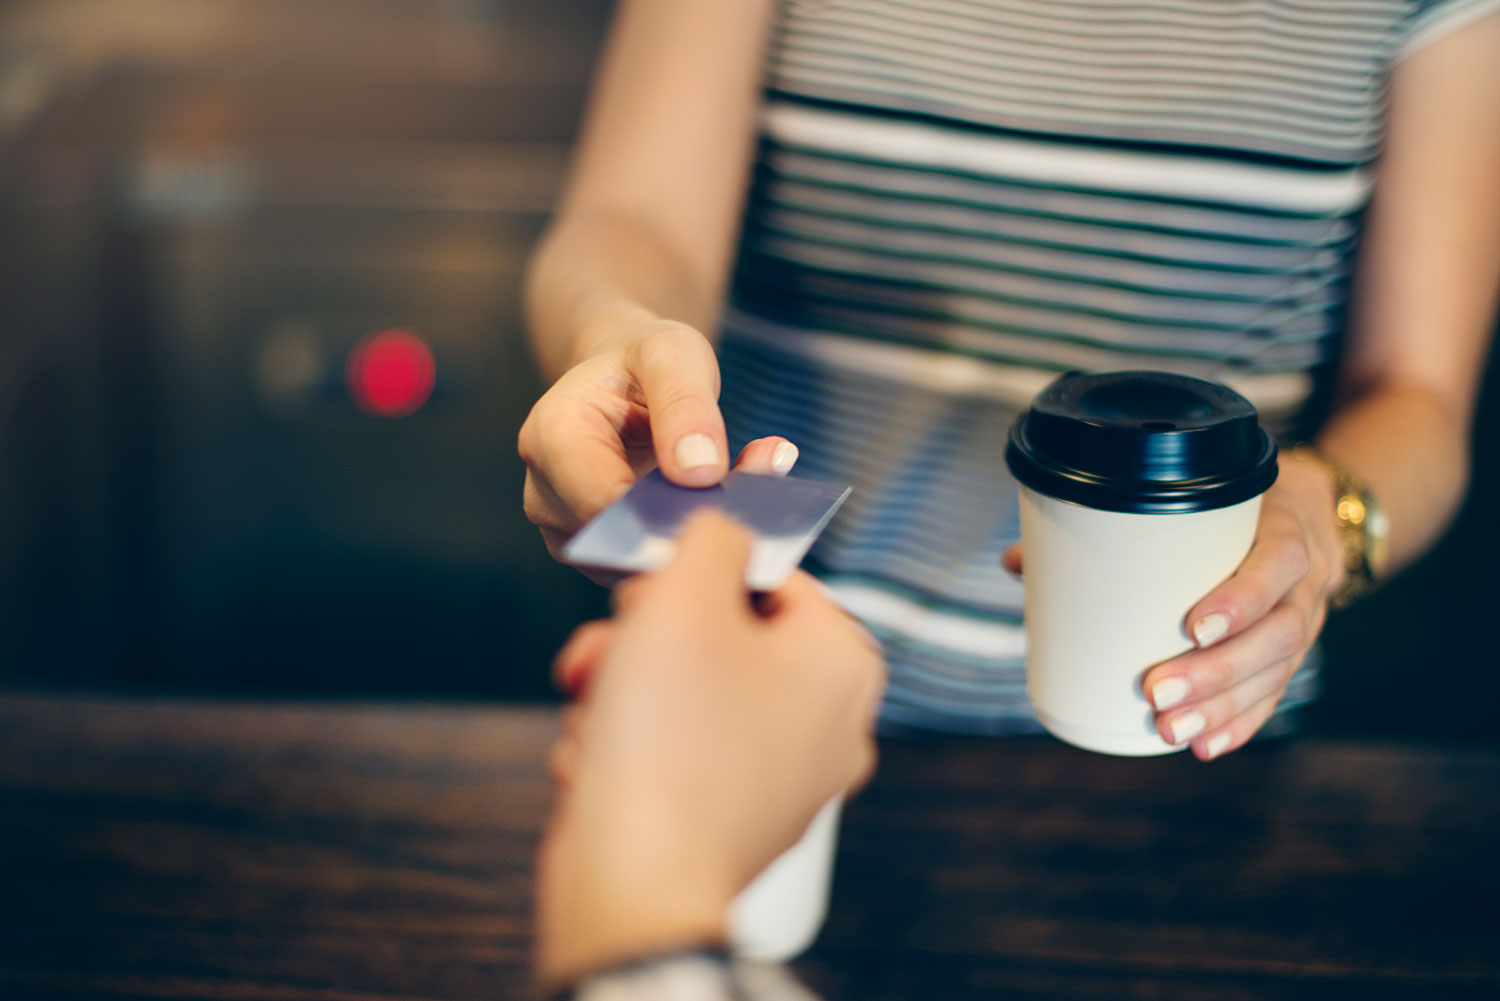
632;326;729;486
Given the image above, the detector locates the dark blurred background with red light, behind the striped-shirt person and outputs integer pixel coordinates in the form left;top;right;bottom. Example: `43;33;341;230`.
0;0;1500;743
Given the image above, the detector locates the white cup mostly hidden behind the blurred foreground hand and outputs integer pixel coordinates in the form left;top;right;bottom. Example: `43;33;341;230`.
729;795;843;962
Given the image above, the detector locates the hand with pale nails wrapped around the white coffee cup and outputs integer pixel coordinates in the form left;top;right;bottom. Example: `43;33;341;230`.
1002;455;1344;761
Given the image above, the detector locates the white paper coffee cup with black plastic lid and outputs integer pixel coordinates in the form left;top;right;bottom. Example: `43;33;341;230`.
1005;372;1277;755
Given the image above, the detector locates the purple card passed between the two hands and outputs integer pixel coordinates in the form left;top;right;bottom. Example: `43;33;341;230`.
563;470;849;591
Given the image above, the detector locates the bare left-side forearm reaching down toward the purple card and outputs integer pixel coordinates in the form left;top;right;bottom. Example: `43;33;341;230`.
527;0;774;378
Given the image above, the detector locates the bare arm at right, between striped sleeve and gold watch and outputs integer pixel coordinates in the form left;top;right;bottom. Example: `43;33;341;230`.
1320;14;1500;579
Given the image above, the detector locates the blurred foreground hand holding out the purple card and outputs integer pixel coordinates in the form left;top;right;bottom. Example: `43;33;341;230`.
537;513;885;983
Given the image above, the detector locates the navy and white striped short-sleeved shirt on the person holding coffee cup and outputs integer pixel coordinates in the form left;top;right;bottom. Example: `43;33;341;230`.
720;0;1500;732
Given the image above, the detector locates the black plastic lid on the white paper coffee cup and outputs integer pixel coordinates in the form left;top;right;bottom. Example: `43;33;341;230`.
1005;372;1277;515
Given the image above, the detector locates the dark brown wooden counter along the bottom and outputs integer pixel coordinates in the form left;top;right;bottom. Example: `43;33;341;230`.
0;695;1500;1001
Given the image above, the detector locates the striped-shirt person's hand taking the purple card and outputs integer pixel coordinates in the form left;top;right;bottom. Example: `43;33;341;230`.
518;321;797;567
